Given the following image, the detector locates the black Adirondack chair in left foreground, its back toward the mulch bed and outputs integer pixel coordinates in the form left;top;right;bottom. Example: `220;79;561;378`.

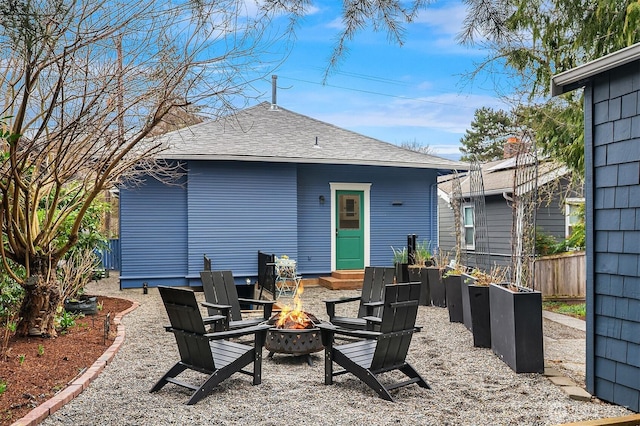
150;286;269;405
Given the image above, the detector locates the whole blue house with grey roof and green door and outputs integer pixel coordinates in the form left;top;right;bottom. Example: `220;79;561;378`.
119;102;465;288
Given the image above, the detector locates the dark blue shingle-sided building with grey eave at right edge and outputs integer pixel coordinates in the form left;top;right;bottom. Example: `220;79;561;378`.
552;43;640;412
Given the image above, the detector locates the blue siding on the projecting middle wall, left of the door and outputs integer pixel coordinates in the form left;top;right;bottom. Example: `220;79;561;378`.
188;161;298;278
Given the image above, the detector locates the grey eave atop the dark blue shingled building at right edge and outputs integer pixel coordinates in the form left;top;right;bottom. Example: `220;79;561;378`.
551;43;640;96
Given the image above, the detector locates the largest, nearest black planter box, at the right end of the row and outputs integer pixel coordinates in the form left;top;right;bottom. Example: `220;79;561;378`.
489;284;544;373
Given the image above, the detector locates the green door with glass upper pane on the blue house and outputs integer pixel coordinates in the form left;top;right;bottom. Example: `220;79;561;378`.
335;191;364;270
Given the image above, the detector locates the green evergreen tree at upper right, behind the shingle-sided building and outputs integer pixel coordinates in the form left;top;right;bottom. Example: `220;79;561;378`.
459;0;640;177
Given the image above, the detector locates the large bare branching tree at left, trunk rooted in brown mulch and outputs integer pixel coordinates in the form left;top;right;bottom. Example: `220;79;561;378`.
0;0;282;336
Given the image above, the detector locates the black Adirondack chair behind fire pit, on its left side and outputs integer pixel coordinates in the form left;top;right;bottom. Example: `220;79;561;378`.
200;271;275;331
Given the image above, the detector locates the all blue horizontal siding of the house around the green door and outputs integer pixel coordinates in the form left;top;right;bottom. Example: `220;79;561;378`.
121;161;437;287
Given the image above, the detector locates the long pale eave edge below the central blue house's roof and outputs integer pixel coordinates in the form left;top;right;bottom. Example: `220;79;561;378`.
161;154;468;170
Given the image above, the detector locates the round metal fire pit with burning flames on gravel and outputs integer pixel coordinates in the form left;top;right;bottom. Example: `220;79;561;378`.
264;287;324;365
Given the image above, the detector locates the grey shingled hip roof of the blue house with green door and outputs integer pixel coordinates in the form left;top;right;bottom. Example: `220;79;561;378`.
155;102;468;170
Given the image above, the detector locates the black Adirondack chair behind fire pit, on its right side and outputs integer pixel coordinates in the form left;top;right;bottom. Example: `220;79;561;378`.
324;266;395;330
